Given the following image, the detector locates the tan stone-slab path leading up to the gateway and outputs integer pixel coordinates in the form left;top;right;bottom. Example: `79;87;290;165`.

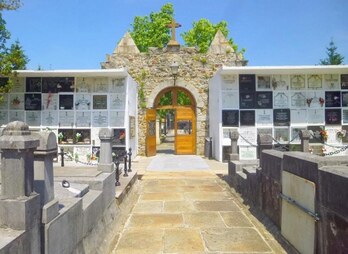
113;171;286;254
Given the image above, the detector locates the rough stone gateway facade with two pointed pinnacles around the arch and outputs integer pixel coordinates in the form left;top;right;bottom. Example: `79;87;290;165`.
102;31;246;155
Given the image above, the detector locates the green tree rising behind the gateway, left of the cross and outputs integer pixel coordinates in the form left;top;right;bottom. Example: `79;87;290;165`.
130;3;174;52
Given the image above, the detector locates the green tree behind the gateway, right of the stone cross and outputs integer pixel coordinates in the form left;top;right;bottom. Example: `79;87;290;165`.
181;18;245;53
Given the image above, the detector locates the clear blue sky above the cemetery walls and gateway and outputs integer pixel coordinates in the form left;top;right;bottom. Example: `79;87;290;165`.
3;0;348;69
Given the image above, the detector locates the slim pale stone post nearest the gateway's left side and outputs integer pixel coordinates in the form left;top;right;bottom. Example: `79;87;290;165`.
98;128;114;173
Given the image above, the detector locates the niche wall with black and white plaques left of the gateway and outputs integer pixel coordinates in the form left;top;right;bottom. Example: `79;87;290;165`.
0;76;135;162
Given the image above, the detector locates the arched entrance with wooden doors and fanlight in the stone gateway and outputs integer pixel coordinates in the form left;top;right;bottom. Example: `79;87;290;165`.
146;87;196;156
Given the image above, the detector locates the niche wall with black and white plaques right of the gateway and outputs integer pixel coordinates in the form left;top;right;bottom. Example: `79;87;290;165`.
220;70;348;160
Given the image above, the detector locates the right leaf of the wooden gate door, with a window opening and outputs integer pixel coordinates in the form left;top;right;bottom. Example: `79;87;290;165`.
175;107;196;154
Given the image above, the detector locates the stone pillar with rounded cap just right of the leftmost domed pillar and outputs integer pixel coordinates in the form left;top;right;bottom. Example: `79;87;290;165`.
34;132;58;206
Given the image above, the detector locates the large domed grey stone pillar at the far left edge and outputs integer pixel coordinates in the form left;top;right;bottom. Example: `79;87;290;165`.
0;121;39;199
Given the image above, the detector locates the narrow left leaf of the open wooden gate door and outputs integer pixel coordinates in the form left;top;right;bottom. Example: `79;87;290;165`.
146;109;156;156
